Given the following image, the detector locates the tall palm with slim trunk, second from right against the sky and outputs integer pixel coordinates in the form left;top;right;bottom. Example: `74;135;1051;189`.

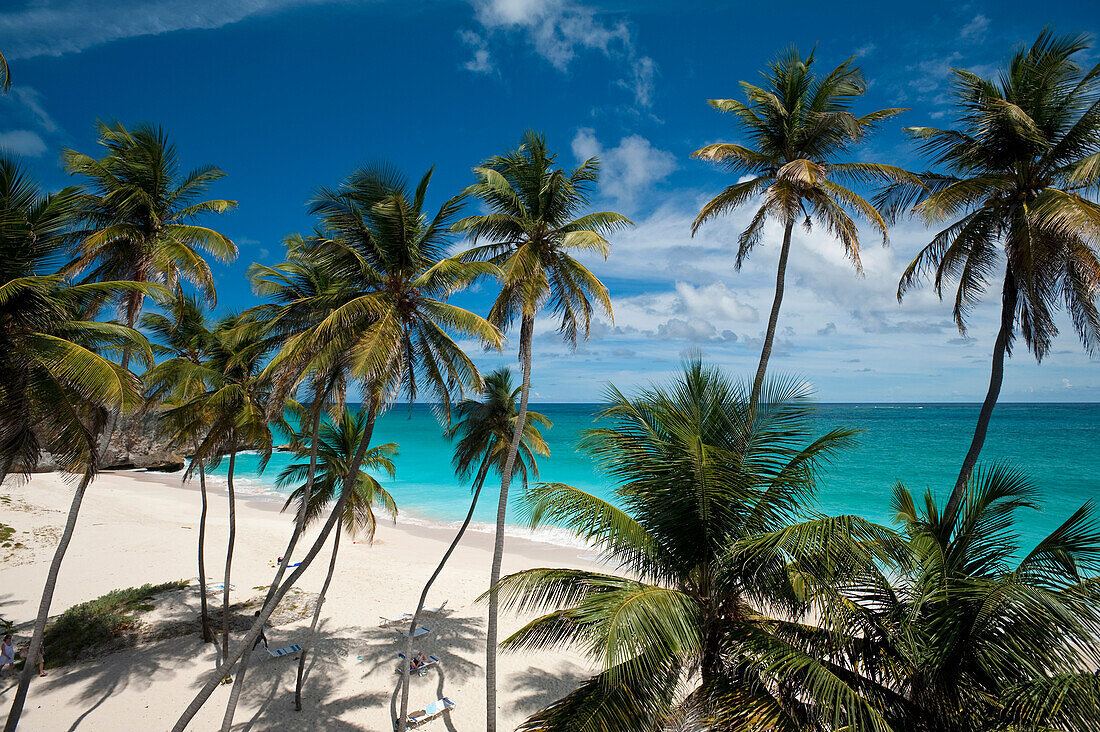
692;48;915;401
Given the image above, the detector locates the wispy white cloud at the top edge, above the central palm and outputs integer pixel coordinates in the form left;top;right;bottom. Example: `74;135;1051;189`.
469;0;657;107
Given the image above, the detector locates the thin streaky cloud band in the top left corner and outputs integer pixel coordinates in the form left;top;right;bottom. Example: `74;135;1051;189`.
0;0;347;61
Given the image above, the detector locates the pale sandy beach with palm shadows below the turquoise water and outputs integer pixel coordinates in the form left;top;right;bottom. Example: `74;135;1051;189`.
0;472;594;732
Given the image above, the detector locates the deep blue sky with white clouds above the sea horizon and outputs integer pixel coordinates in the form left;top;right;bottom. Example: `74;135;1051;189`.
0;0;1100;402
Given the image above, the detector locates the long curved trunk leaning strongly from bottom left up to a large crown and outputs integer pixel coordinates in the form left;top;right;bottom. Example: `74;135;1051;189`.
202;392;382;732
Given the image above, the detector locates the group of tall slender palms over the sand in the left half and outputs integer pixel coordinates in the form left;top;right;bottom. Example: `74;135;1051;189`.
0;110;628;729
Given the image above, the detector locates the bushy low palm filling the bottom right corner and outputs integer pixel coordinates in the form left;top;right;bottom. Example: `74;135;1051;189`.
827;467;1100;732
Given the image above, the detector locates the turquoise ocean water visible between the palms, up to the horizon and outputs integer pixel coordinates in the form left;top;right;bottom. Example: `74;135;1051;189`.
204;404;1100;545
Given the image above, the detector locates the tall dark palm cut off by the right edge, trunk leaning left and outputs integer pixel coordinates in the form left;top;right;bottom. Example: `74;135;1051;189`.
878;30;1100;514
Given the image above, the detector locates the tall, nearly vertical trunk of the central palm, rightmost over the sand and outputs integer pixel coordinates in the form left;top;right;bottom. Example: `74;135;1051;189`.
485;314;535;732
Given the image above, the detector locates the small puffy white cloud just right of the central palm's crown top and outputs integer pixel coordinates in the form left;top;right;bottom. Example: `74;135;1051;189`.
573;128;677;206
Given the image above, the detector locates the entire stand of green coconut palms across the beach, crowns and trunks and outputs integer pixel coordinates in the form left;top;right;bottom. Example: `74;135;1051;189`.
0;27;1100;732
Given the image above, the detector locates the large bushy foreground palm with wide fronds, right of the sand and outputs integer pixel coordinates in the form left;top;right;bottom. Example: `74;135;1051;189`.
497;360;889;732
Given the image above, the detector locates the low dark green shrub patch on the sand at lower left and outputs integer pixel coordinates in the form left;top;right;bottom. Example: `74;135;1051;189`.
45;580;187;668
